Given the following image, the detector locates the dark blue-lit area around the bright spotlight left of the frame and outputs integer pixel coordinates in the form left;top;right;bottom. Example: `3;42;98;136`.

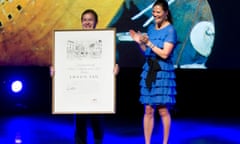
0;66;52;114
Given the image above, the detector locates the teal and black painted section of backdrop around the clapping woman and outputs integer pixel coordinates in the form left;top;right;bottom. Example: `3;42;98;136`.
111;0;215;68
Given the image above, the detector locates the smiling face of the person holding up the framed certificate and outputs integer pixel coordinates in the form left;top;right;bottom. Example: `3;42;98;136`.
82;13;97;29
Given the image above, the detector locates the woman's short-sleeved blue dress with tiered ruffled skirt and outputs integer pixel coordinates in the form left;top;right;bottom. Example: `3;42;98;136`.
139;24;177;107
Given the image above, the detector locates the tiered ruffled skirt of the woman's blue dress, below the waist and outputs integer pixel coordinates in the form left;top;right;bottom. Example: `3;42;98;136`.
139;61;177;107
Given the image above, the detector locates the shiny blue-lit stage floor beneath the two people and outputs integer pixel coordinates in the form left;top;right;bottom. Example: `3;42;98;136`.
0;114;240;144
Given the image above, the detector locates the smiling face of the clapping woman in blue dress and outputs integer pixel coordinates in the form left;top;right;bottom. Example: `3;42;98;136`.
152;5;168;24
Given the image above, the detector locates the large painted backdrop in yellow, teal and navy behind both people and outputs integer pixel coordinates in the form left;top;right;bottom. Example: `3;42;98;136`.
0;0;240;69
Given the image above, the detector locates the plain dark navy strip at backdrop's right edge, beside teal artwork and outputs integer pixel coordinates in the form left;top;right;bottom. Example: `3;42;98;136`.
207;0;240;69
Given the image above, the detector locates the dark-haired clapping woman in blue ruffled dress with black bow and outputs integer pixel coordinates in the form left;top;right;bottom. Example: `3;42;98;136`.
129;0;177;144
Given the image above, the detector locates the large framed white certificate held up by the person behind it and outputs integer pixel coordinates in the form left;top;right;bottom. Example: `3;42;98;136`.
52;28;116;114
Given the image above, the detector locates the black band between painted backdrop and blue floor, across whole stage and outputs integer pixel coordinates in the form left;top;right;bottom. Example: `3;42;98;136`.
0;67;240;118
